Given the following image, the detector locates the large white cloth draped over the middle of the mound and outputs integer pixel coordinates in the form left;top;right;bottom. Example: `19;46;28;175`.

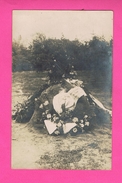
53;86;86;115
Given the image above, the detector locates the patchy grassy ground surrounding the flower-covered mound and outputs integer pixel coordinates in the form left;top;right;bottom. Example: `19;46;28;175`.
12;71;112;170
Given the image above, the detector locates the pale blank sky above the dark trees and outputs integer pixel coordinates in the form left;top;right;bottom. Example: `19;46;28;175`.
12;10;113;46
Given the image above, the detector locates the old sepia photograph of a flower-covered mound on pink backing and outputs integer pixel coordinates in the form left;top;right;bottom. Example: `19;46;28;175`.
11;10;113;170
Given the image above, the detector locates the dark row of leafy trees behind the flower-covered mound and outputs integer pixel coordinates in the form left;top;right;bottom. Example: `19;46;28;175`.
12;34;112;87
